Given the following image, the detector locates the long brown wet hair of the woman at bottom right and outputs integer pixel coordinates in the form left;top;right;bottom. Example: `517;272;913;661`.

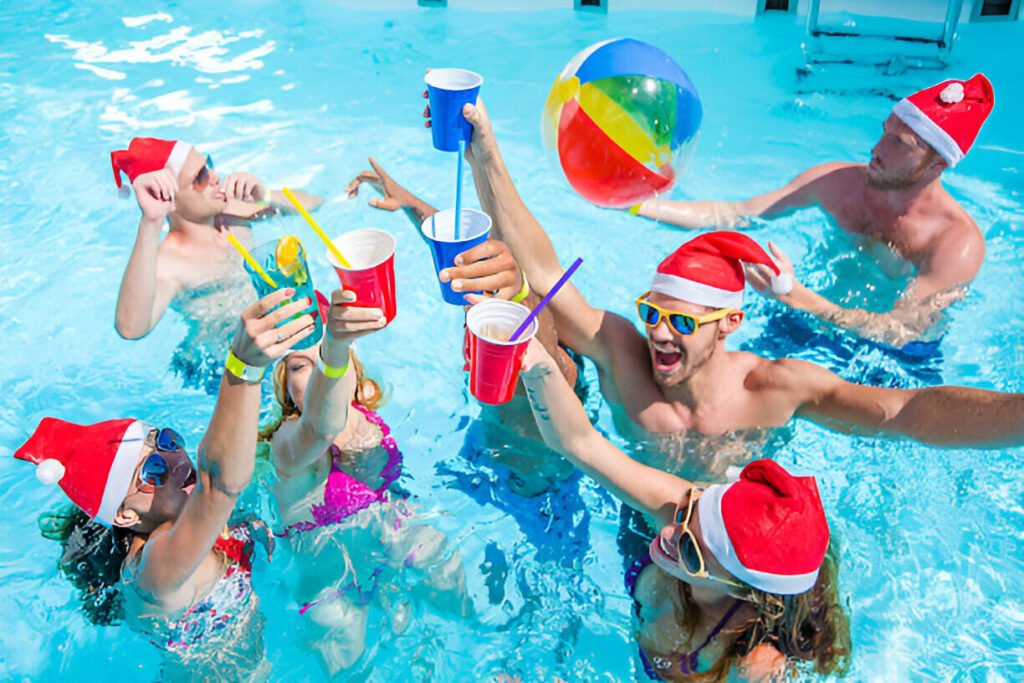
678;544;851;680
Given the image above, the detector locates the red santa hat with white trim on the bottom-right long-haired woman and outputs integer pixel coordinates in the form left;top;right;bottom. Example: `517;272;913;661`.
697;460;828;595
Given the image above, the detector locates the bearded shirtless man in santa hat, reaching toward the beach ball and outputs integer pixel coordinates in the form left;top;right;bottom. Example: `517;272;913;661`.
635;74;992;347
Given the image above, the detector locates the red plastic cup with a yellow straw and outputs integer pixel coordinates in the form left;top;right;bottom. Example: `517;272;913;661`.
327;227;398;323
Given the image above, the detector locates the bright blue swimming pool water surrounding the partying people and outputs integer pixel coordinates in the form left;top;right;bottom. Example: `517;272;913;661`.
0;1;1024;681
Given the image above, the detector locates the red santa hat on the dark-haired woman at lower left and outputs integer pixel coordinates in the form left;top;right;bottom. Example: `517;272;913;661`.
14;418;153;526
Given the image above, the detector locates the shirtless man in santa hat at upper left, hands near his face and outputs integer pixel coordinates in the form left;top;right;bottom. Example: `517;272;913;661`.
111;138;321;339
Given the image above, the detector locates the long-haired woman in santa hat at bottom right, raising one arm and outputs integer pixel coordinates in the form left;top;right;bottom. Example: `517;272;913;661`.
522;342;850;681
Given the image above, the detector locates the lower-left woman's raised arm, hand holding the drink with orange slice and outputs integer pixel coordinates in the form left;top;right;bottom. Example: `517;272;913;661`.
139;289;313;600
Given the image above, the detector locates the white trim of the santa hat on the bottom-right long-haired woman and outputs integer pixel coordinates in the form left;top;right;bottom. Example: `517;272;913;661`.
697;482;818;595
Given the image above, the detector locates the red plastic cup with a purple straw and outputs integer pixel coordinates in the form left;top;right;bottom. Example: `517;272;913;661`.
466;299;537;405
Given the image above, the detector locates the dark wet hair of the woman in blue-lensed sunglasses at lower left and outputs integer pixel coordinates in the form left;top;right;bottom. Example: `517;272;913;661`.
38;506;133;626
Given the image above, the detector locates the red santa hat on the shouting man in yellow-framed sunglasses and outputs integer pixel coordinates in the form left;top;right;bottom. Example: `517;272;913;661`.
650;231;793;308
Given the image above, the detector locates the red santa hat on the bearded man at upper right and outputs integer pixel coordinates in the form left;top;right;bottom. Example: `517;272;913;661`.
893;74;994;168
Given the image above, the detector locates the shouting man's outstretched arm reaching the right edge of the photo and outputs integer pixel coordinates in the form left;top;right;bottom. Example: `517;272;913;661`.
770;359;1024;449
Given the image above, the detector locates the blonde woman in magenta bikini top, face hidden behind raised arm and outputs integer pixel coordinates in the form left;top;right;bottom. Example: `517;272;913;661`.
264;290;471;676
